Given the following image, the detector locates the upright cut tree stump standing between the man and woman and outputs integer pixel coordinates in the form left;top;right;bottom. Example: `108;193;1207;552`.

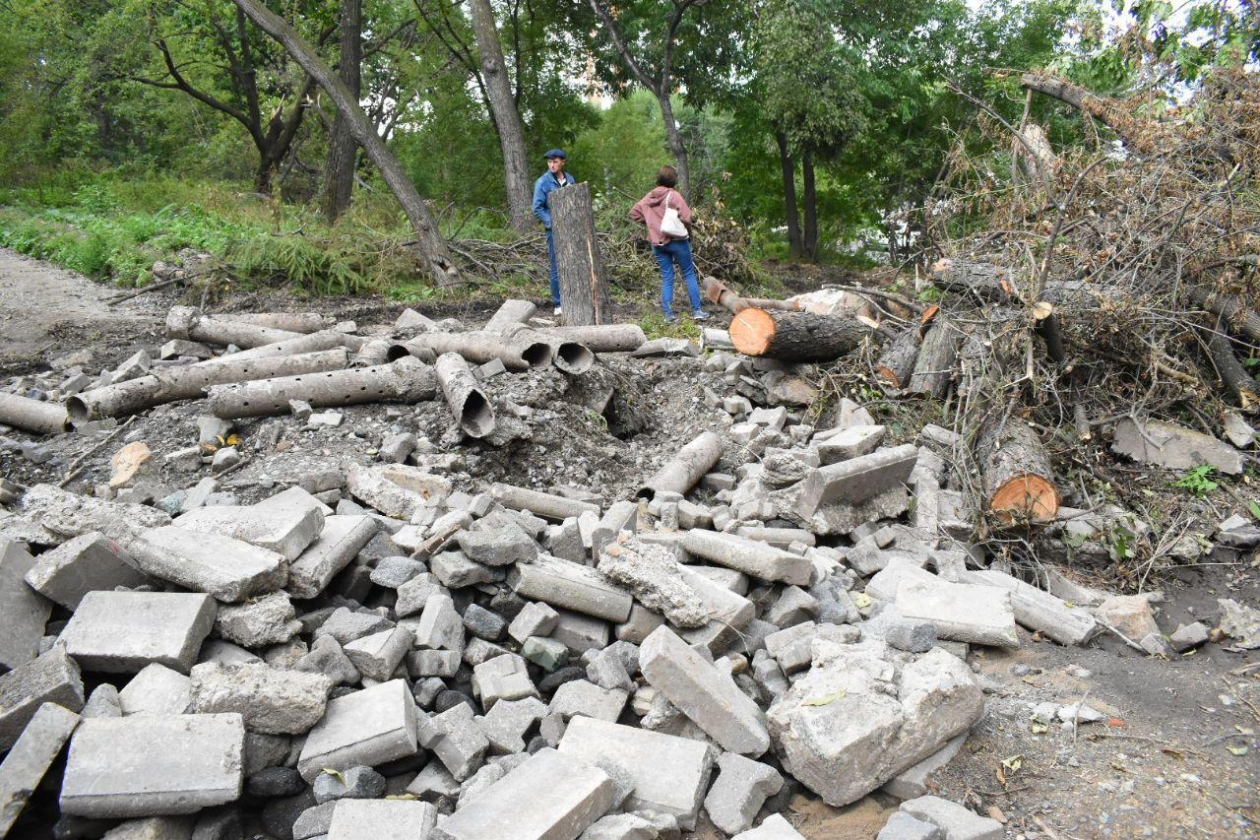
551;184;609;326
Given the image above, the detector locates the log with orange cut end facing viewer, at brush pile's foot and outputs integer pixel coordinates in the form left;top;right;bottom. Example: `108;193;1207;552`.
975;413;1058;524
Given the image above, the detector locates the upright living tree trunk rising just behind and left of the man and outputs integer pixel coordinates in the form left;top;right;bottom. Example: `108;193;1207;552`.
471;0;536;233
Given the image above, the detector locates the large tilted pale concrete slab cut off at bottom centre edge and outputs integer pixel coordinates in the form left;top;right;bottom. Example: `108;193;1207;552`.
430;749;614;840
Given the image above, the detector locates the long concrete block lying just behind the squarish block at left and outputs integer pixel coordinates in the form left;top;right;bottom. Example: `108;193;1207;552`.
129;525;289;603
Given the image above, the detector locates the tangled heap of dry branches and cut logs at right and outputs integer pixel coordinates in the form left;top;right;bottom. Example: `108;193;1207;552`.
892;71;1260;546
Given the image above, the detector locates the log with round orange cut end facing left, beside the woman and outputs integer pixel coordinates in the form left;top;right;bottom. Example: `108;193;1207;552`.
730;307;874;361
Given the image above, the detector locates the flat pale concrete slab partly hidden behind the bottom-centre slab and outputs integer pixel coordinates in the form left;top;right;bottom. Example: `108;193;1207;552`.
559;717;713;831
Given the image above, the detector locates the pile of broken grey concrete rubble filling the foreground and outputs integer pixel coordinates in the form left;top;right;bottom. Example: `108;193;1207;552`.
0;298;1260;840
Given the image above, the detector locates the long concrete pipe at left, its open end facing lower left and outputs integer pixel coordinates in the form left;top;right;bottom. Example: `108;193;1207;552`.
66;348;350;423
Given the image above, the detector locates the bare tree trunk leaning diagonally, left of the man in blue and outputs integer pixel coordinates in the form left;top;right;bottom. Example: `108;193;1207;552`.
233;0;464;286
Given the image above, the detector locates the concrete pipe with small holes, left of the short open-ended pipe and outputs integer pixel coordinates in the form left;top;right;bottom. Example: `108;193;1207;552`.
208;356;437;419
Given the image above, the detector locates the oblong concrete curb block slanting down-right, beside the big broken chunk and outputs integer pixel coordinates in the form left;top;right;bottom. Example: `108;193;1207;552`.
639;627;770;756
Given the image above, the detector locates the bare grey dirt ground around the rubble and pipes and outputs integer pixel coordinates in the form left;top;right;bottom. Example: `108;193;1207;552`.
0;251;1260;840
